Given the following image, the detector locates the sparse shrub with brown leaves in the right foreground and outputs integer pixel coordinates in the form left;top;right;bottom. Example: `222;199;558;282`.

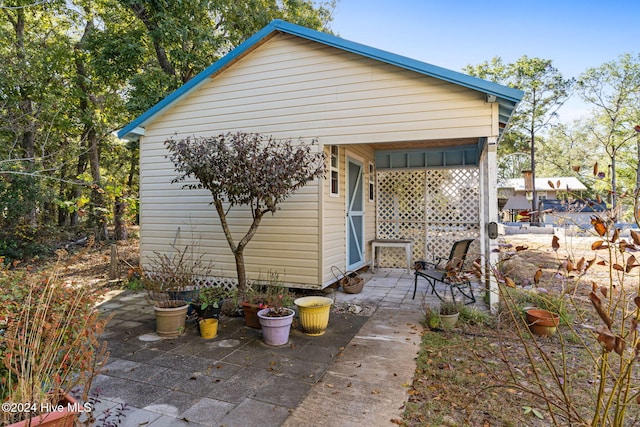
498;215;640;426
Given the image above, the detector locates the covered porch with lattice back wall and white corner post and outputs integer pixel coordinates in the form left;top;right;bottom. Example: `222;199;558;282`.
342;137;498;309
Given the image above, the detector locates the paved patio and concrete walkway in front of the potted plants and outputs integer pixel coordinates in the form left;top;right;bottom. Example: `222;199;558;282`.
94;269;484;427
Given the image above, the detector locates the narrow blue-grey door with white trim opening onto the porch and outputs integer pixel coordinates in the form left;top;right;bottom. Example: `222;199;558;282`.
347;158;364;270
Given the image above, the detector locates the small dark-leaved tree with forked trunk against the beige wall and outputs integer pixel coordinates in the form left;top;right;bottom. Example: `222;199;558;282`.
165;132;325;299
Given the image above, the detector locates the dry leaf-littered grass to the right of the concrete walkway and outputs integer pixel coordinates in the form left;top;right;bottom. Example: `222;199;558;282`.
394;235;640;426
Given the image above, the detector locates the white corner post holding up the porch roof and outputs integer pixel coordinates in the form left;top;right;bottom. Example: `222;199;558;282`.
480;137;499;313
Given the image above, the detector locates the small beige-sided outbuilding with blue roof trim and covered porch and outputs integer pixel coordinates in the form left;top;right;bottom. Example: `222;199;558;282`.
119;20;523;296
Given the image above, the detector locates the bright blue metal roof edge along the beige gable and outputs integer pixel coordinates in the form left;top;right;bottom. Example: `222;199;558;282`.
118;19;524;139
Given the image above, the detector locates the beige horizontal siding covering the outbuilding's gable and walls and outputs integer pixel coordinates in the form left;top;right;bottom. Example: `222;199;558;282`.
140;34;496;287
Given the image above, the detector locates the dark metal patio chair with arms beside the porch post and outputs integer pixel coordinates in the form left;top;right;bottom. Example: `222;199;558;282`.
413;239;476;304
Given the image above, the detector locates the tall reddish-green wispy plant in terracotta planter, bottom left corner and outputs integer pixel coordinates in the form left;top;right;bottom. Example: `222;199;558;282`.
0;260;108;427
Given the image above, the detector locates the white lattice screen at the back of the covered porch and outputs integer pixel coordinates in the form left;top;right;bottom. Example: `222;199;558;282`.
377;168;480;268
